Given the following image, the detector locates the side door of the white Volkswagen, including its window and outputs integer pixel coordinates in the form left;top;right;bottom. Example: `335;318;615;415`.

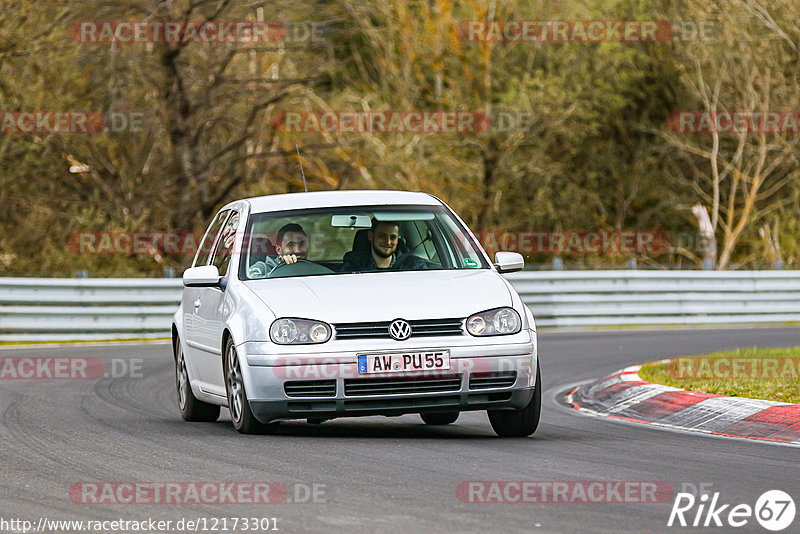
193;210;240;395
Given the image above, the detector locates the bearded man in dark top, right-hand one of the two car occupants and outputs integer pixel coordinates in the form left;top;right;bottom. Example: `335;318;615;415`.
342;219;427;272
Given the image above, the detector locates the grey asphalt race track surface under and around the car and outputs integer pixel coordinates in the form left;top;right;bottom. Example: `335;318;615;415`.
0;327;800;533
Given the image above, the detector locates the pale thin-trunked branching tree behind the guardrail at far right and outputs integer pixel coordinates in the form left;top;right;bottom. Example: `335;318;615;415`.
662;0;800;269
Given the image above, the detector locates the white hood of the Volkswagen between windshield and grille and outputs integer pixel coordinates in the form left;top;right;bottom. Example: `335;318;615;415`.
245;269;512;323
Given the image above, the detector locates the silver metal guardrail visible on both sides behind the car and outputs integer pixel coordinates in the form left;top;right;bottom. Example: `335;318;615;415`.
0;271;800;341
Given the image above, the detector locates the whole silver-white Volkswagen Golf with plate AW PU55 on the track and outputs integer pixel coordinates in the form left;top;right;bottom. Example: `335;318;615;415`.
172;191;541;437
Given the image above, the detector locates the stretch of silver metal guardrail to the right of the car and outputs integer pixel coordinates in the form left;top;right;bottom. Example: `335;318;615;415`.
507;271;800;327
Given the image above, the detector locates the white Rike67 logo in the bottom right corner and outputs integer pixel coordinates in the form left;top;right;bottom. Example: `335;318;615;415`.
667;490;795;532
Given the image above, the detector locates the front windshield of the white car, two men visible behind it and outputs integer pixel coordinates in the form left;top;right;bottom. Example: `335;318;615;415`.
239;206;489;280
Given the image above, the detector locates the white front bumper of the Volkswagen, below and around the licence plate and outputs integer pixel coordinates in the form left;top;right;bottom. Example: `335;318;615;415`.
237;332;537;423
